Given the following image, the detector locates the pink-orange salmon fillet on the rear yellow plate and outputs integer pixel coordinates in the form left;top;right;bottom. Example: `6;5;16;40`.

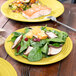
22;4;51;19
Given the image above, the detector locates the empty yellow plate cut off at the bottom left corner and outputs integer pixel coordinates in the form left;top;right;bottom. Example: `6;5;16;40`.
0;58;17;76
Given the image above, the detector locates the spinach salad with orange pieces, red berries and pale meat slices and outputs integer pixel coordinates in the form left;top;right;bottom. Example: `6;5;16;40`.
10;26;68;61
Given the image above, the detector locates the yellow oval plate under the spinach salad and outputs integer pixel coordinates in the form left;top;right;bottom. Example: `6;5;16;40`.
5;26;73;65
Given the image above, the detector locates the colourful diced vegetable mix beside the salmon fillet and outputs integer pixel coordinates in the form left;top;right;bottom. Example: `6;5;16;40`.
9;0;31;13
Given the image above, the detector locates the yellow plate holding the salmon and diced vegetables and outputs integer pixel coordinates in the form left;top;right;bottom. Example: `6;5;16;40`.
1;0;64;22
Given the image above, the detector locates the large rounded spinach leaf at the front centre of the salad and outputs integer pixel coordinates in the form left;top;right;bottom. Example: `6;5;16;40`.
28;47;42;61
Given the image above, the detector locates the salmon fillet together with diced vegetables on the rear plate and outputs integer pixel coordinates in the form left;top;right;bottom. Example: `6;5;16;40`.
9;0;51;19
